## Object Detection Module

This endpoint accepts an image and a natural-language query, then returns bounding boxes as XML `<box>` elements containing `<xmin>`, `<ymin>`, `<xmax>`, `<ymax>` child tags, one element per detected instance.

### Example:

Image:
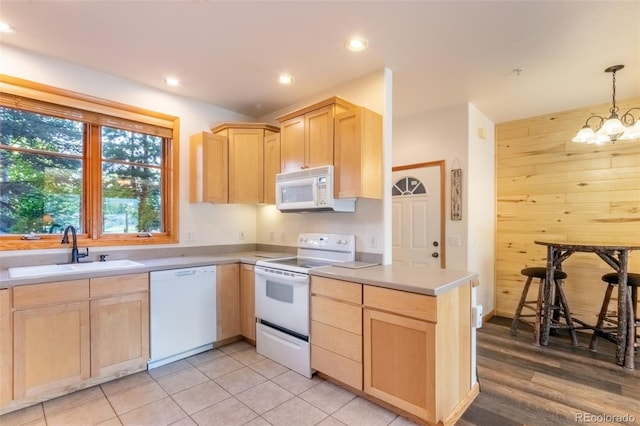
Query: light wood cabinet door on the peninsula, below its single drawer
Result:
<box><xmin>364</xmin><ymin>309</ymin><xmax>435</xmax><ymax>420</ymax></box>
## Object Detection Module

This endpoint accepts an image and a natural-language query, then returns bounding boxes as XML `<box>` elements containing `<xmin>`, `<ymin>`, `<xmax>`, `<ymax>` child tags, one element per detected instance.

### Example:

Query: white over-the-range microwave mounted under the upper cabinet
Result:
<box><xmin>276</xmin><ymin>165</ymin><xmax>356</xmax><ymax>212</ymax></box>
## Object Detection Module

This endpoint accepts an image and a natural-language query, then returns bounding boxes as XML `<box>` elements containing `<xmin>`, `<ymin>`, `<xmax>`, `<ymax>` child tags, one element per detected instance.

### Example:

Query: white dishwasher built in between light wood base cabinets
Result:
<box><xmin>147</xmin><ymin>265</ymin><xmax>216</xmax><ymax>370</ymax></box>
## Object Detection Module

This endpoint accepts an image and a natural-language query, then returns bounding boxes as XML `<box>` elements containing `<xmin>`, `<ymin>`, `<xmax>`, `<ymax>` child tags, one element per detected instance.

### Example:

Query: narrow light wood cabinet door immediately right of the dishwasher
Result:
<box><xmin>216</xmin><ymin>263</ymin><xmax>240</xmax><ymax>340</ymax></box>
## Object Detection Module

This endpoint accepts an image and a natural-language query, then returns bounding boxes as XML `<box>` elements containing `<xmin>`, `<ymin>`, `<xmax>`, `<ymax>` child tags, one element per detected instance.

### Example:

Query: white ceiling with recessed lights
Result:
<box><xmin>0</xmin><ymin>0</ymin><xmax>640</xmax><ymax>123</ymax></box>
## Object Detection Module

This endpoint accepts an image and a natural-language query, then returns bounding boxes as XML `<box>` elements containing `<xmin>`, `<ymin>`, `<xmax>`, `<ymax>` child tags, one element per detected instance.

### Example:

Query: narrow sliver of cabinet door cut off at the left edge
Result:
<box><xmin>0</xmin><ymin>288</ymin><xmax>13</xmax><ymax>408</ymax></box>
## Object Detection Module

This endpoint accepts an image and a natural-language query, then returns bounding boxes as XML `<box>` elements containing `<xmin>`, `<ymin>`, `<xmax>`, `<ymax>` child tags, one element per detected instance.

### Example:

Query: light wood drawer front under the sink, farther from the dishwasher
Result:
<box><xmin>13</xmin><ymin>280</ymin><xmax>89</xmax><ymax>309</ymax></box>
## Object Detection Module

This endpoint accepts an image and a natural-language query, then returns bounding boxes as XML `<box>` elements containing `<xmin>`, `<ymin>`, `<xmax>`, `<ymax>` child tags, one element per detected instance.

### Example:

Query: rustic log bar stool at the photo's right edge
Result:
<box><xmin>589</xmin><ymin>272</ymin><xmax>640</xmax><ymax>351</ymax></box>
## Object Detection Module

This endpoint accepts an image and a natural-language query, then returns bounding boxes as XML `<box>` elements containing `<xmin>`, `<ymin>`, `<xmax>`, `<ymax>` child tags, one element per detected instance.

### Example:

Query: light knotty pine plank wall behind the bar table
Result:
<box><xmin>496</xmin><ymin>98</ymin><xmax>640</xmax><ymax>324</ymax></box>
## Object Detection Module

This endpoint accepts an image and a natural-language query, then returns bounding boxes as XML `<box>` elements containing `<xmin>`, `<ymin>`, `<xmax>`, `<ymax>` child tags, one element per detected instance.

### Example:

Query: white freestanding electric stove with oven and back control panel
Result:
<box><xmin>255</xmin><ymin>233</ymin><xmax>355</xmax><ymax>378</ymax></box>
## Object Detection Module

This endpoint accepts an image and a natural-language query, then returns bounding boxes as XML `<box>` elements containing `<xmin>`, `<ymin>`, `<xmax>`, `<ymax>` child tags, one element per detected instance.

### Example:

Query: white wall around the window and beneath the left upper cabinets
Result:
<box><xmin>0</xmin><ymin>45</ymin><xmax>256</xmax><ymax>254</ymax></box>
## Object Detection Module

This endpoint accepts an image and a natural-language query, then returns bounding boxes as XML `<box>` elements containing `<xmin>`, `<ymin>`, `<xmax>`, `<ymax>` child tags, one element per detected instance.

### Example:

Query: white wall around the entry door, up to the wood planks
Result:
<box><xmin>393</xmin><ymin>104</ymin><xmax>495</xmax><ymax>313</ymax></box>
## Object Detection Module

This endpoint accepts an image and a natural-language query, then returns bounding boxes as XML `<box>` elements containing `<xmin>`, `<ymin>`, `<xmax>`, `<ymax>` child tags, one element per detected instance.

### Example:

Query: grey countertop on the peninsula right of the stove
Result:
<box><xmin>311</xmin><ymin>265</ymin><xmax>478</xmax><ymax>296</ymax></box>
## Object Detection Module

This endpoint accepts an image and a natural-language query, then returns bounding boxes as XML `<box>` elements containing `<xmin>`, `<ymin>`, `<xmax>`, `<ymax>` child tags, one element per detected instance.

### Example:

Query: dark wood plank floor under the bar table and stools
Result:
<box><xmin>457</xmin><ymin>318</ymin><xmax>640</xmax><ymax>426</ymax></box>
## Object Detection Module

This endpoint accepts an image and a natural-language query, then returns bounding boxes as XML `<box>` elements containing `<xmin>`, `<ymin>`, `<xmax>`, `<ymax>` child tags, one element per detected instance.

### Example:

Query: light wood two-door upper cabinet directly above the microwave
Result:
<box><xmin>276</xmin><ymin>96</ymin><xmax>356</xmax><ymax>172</ymax></box>
